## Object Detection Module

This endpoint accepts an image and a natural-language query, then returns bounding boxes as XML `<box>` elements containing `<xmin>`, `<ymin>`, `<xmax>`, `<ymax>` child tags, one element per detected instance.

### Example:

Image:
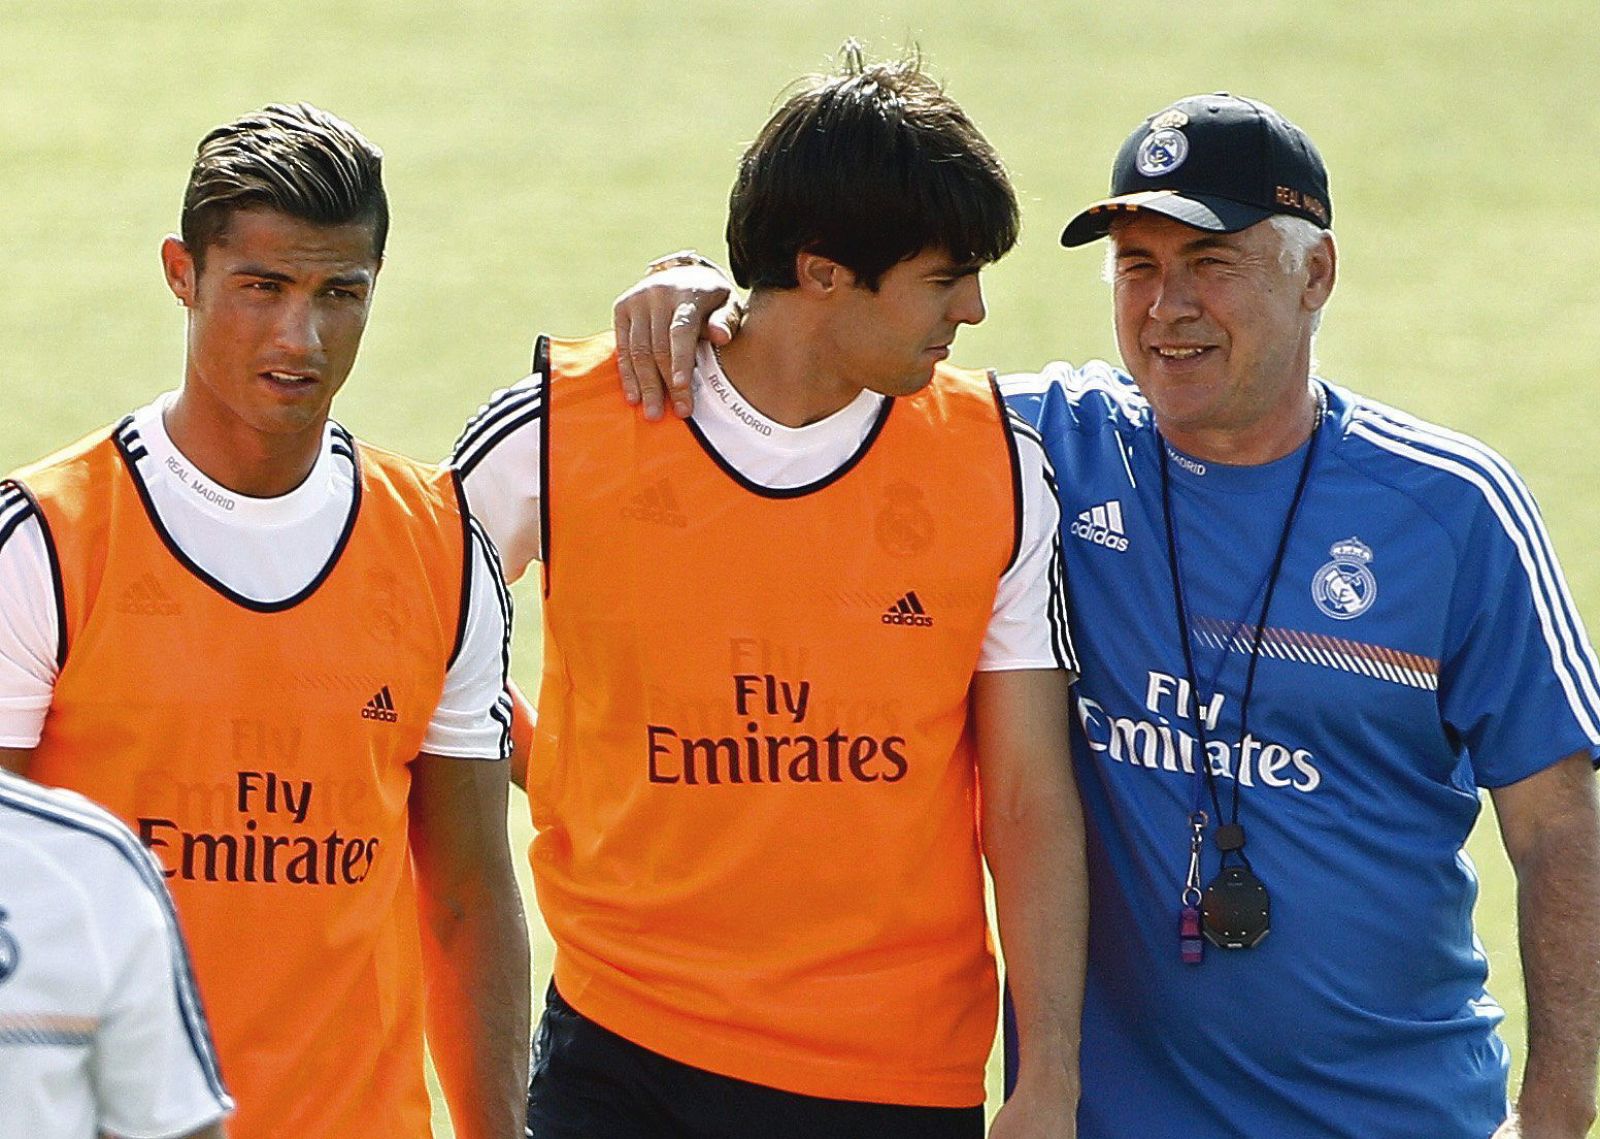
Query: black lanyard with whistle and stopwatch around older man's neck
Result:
<box><xmin>1155</xmin><ymin>386</ymin><xmax>1326</xmax><ymax>965</ymax></box>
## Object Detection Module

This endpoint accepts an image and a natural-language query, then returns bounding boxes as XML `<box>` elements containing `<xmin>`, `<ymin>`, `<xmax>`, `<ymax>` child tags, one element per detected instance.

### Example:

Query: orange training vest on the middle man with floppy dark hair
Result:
<box><xmin>528</xmin><ymin>336</ymin><xmax>1018</xmax><ymax>1107</ymax></box>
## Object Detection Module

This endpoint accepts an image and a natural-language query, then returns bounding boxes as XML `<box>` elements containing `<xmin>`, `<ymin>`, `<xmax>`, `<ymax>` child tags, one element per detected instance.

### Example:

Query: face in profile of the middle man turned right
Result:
<box><xmin>830</xmin><ymin>250</ymin><xmax>984</xmax><ymax>395</ymax></box>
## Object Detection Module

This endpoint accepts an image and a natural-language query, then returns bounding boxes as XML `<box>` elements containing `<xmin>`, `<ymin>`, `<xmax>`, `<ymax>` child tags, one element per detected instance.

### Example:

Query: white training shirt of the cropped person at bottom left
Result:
<box><xmin>0</xmin><ymin>773</ymin><xmax>234</xmax><ymax>1139</ymax></box>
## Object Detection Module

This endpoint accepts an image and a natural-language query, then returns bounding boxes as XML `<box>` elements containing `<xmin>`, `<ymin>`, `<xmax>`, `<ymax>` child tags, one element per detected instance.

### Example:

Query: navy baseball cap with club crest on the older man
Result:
<box><xmin>1061</xmin><ymin>93</ymin><xmax>1333</xmax><ymax>246</ymax></box>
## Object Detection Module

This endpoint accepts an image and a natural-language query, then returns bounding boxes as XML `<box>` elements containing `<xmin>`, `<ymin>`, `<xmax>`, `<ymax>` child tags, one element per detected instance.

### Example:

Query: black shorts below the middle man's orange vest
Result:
<box><xmin>528</xmin><ymin>984</ymin><xmax>984</xmax><ymax>1139</ymax></box>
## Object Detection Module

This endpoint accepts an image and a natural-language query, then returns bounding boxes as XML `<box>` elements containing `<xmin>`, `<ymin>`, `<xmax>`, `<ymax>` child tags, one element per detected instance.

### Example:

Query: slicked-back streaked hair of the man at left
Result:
<box><xmin>179</xmin><ymin>102</ymin><xmax>389</xmax><ymax>269</ymax></box>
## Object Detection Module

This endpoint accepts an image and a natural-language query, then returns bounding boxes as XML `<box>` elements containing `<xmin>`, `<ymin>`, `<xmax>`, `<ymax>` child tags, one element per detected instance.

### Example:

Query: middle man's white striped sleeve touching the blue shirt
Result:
<box><xmin>978</xmin><ymin>414</ymin><xmax>1078</xmax><ymax>673</ymax></box>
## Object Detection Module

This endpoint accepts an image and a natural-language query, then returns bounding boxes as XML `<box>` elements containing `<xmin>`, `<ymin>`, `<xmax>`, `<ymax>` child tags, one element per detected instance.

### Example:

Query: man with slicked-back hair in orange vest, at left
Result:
<box><xmin>0</xmin><ymin>104</ymin><xmax>528</xmax><ymax>1139</ymax></box>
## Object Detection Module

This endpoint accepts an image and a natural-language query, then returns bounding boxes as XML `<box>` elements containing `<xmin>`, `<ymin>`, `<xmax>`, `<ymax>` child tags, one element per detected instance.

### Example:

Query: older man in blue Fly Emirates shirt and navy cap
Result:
<box><xmin>621</xmin><ymin>86</ymin><xmax>1600</xmax><ymax>1139</ymax></box>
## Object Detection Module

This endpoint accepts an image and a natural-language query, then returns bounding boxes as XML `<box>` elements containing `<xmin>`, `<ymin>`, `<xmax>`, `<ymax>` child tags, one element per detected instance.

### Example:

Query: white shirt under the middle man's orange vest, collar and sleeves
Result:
<box><xmin>448</xmin><ymin>341</ymin><xmax>1075</xmax><ymax>672</ymax></box>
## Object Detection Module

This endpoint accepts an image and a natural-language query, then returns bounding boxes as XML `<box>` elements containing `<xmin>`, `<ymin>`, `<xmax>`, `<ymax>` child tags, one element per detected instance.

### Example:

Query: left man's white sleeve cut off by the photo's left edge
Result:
<box><xmin>0</xmin><ymin>485</ymin><xmax>59</xmax><ymax>747</ymax></box>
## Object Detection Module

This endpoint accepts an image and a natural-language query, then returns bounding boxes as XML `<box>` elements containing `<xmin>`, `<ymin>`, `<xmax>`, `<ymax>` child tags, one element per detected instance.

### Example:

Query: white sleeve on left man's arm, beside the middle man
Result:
<box><xmin>422</xmin><ymin>520</ymin><xmax>510</xmax><ymax>760</ymax></box>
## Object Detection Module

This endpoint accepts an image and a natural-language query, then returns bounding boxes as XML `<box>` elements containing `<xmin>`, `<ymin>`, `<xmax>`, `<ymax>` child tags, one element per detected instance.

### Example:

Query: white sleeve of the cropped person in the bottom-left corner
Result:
<box><xmin>90</xmin><ymin>835</ymin><xmax>234</xmax><ymax>1139</ymax></box>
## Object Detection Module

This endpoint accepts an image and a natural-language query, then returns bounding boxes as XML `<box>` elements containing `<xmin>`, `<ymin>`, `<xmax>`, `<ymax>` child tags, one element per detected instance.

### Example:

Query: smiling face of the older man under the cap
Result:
<box><xmin>1110</xmin><ymin>210</ymin><xmax>1333</xmax><ymax>451</ymax></box>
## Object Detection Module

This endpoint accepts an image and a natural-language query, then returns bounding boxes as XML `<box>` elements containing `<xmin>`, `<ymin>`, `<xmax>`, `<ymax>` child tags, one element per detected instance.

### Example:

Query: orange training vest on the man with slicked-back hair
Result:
<box><xmin>18</xmin><ymin>432</ymin><xmax>466</xmax><ymax>1139</ymax></box>
